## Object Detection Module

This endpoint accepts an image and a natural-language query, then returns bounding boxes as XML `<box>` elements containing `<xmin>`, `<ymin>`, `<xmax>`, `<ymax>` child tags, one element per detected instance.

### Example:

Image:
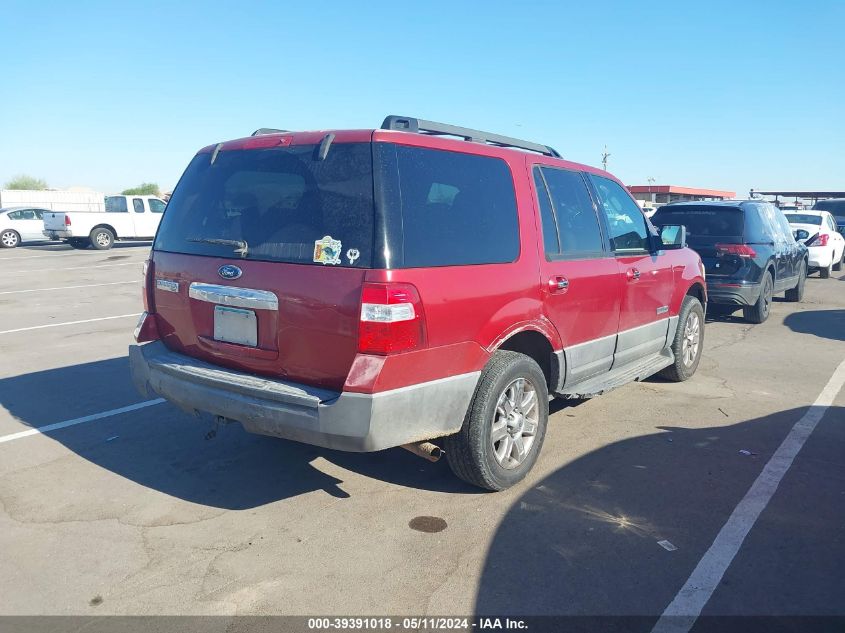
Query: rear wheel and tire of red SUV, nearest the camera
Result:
<box><xmin>444</xmin><ymin>351</ymin><xmax>549</xmax><ymax>490</ymax></box>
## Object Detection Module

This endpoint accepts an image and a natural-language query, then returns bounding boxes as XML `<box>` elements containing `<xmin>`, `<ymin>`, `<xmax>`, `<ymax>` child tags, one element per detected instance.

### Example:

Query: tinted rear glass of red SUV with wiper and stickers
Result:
<box><xmin>155</xmin><ymin>143</ymin><xmax>375</xmax><ymax>268</ymax></box>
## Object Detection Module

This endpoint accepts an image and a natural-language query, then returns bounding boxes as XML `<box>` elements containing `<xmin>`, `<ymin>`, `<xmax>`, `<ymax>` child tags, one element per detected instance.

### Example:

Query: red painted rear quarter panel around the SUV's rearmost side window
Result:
<box><xmin>354</xmin><ymin>144</ymin><xmax>548</xmax><ymax>391</ymax></box>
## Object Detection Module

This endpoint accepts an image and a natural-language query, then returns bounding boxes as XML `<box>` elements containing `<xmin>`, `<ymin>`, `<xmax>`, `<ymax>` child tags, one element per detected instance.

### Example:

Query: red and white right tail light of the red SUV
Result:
<box><xmin>358</xmin><ymin>283</ymin><xmax>426</xmax><ymax>355</ymax></box>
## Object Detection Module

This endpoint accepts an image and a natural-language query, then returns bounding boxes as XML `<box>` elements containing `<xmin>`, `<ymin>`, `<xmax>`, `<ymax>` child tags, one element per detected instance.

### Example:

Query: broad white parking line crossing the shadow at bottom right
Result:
<box><xmin>652</xmin><ymin>360</ymin><xmax>845</xmax><ymax>633</ymax></box>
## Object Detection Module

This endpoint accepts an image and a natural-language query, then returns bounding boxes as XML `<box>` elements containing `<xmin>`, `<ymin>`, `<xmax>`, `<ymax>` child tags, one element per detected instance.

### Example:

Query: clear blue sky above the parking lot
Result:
<box><xmin>0</xmin><ymin>0</ymin><xmax>845</xmax><ymax>195</ymax></box>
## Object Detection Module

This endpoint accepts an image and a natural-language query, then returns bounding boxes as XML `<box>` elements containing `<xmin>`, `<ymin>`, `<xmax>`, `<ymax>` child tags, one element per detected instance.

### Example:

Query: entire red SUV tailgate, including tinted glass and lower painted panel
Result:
<box><xmin>152</xmin><ymin>136</ymin><xmax>375</xmax><ymax>391</ymax></box>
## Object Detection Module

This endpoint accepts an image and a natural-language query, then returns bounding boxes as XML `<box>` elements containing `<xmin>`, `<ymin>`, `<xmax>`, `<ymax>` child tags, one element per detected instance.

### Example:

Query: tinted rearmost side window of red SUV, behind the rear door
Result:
<box><xmin>380</xmin><ymin>143</ymin><xmax>519</xmax><ymax>268</ymax></box>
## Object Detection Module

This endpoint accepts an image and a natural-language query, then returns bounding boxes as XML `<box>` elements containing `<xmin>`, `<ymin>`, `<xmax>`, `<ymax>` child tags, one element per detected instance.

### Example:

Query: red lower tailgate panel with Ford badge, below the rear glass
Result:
<box><xmin>152</xmin><ymin>252</ymin><xmax>365</xmax><ymax>391</ymax></box>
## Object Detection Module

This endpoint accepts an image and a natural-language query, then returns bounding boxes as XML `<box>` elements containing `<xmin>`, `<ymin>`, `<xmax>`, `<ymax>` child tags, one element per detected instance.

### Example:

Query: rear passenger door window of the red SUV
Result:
<box><xmin>535</xmin><ymin>167</ymin><xmax>604</xmax><ymax>259</ymax></box>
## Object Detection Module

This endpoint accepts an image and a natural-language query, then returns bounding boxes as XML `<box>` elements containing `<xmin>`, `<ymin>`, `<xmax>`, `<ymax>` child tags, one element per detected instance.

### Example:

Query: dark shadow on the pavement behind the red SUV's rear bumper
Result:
<box><xmin>0</xmin><ymin>357</ymin><xmax>483</xmax><ymax>510</ymax></box>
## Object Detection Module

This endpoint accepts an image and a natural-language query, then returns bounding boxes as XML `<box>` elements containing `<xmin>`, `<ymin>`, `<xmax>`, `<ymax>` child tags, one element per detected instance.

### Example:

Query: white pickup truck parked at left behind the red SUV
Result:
<box><xmin>43</xmin><ymin>196</ymin><xmax>165</xmax><ymax>250</ymax></box>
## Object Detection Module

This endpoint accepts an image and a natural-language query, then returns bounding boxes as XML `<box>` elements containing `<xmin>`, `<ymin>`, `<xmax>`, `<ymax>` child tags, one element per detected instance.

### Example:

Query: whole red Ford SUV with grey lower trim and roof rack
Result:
<box><xmin>129</xmin><ymin>116</ymin><xmax>706</xmax><ymax>490</ymax></box>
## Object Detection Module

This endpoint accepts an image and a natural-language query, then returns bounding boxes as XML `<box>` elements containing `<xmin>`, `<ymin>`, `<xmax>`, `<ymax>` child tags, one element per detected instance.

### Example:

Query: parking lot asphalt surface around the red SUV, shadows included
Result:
<box><xmin>0</xmin><ymin>244</ymin><xmax>845</xmax><ymax>630</ymax></box>
